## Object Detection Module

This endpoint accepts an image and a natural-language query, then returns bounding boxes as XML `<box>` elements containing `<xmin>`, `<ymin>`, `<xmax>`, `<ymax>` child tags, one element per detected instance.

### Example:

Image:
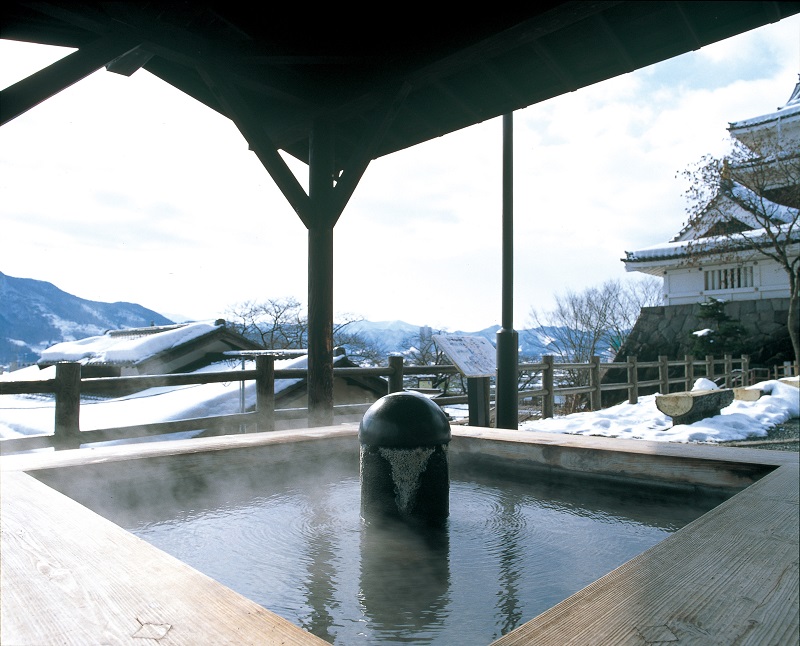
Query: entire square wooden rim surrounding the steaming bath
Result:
<box><xmin>0</xmin><ymin>425</ymin><xmax>800</xmax><ymax>646</ymax></box>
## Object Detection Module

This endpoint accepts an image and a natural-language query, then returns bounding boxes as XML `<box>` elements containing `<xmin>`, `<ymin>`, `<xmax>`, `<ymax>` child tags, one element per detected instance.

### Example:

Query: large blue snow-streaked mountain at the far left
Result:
<box><xmin>0</xmin><ymin>272</ymin><xmax>172</xmax><ymax>368</ymax></box>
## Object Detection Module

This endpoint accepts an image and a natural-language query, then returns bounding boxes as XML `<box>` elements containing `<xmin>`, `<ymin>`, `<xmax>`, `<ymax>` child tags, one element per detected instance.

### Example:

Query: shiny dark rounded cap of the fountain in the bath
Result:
<box><xmin>358</xmin><ymin>391</ymin><xmax>451</xmax><ymax>448</ymax></box>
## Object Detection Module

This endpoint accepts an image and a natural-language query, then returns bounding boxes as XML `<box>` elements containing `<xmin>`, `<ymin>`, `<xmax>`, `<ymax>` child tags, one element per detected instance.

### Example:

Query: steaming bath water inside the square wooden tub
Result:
<box><xmin>56</xmin><ymin>459</ymin><xmax>721</xmax><ymax>645</ymax></box>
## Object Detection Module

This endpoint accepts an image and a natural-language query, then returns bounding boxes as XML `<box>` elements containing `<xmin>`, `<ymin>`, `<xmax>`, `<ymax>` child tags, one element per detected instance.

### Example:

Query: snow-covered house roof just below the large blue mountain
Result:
<box><xmin>38</xmin><ymin>322</ymin><xmax>224</xmax><ymax>366</ymax></box>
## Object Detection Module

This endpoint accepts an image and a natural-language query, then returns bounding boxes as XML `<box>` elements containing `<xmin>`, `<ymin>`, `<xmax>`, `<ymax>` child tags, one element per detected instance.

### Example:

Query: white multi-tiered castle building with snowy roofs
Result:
<box><xmin>622</xmin><ymin>83</ymin><xmax>800</xmax><ymax>306</ymax></box>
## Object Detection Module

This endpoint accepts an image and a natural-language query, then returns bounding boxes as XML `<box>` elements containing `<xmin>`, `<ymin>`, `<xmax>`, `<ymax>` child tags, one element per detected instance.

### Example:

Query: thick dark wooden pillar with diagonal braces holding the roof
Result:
<box><xmin>308</xmin><ymin>123</ymin><xmax>332</xmax><ymax>426</ymax></box>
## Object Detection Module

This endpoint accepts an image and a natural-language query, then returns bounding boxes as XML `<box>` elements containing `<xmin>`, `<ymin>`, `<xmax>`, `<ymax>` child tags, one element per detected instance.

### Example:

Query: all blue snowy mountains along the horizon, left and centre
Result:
<box><xmin>0</xmin><ymin>272</ymin><xmax>564</xmax><ymax>370</ymax></box>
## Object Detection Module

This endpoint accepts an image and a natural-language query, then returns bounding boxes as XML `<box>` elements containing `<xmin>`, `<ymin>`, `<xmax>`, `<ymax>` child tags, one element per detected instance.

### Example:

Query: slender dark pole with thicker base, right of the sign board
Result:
<box><xmin>495</xmin><ymin>113</ymin><xmax>519</xmax><ymax>428</ymax></box>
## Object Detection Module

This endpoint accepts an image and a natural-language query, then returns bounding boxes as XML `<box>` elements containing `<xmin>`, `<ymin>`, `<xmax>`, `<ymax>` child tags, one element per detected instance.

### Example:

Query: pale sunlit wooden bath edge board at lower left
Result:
<box><xmin>0</xmin><ymin>472</ymin><xmax>326</xmax><ymax>646</ymax></box>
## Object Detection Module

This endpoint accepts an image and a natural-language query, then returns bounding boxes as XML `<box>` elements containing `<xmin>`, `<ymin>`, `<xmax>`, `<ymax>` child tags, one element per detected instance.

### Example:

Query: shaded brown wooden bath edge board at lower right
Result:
<box><xmin>494</xmin><ymin>466</ymin><xmax>799</xmax><ymax>646</ymax></box>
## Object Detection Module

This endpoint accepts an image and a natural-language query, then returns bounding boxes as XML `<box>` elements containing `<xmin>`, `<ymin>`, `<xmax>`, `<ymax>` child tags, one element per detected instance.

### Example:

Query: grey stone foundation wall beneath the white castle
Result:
<box><xmin>616</xmin><ymin>298</ymin><xmax>793</xmax><ymax>366</ymax></box>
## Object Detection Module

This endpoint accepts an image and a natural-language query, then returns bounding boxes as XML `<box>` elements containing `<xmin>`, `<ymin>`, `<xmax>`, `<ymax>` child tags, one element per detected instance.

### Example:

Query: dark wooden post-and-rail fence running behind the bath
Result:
<box><xmin>0</xmin><ymin>355</ymin><xmax>764</xmax><ymax>453</ymax></box>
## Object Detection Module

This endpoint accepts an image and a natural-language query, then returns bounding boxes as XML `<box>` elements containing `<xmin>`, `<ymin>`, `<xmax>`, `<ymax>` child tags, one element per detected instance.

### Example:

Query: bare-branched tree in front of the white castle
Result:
<box><xmin>681</xmin><ymin>131</ymin><xmax>800</xmax><ymax>363</ymax></box>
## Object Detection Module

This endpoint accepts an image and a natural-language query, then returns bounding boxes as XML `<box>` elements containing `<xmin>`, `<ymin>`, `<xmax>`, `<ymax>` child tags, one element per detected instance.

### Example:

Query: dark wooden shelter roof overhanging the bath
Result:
<box><xmin>6</xmin><ymin>0</ymin><xmax>800</xmax><ymax>176</ymax></box>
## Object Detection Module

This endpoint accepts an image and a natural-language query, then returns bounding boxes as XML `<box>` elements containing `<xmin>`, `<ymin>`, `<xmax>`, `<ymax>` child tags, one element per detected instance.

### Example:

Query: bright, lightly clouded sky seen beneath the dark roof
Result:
<box><xmin>0</xmin><ymin>16</ymin><xmax>800</xmax><ymax>331</ymax></box>
